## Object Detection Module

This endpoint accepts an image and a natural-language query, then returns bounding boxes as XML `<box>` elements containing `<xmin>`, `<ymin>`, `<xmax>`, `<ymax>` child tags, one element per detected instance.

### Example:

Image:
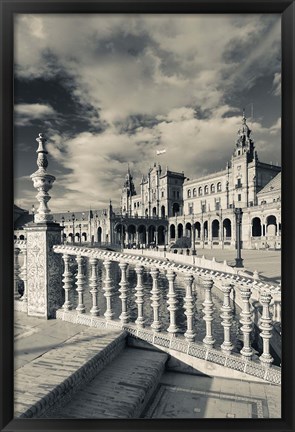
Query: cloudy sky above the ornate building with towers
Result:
<box><xmin>14</xmin><ymin>14</ymin><xmax>281</xmax><ymax>211</ymax></box>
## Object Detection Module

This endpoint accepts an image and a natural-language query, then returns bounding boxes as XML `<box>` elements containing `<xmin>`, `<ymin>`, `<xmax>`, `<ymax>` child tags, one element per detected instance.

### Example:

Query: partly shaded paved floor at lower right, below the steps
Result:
<box><xmin>144</xmin><ymin>372</ymin><xmax>281</xmax><ymax>418</ymax></box>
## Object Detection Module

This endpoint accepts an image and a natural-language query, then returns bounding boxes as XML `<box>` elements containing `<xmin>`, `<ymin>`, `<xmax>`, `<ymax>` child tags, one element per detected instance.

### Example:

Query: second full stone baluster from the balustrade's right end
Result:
<box><xmin>240</xmin><ymin>286</ymin><xmax>253</xmax><ymax>360</ymax></box>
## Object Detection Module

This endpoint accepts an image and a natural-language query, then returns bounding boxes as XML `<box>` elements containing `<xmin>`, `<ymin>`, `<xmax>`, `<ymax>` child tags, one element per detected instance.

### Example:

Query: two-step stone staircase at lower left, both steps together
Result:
<box><xmin>14</xmin><ymin>328</ymin><xmax>168</xmax><ymax>418</ymax></box>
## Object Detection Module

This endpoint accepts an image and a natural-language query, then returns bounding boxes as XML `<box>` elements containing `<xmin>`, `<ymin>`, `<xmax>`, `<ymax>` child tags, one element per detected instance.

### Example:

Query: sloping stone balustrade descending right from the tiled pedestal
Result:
<box><xmin>49</xmin><ymin>245</ymin><xmax>280</xmax><ymax>384</ymax></box>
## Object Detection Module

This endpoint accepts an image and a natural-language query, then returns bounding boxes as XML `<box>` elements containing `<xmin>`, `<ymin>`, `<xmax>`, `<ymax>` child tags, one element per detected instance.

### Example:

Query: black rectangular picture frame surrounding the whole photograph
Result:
<box><xmin>0</xmin><ymin>0</ymin><xmax>295</xmax><ymax>432</ymax></box>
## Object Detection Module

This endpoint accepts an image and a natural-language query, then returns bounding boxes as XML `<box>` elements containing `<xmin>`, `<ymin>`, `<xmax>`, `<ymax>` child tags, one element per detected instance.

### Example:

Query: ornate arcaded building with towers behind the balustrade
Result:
<box><xmin>15</xmin><ymin>116</ymin><xmax>281</xmax><ymax>249</ymax></box>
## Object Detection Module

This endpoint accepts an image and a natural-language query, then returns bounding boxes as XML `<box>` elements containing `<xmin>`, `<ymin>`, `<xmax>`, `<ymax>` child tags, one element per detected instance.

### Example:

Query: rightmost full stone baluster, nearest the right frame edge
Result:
<box><xmin>259</xmin><ymin>292</ymin><xmax>273</xmax><ymax>366</ymax></box>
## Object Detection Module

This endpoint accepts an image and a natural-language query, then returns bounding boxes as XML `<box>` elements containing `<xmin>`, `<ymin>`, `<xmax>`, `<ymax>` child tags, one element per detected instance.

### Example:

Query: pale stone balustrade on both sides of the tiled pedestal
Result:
<box><xmin>15</xmin><ymin>241</ymin><xmax>280</xmax><ymax>383</ymax></box>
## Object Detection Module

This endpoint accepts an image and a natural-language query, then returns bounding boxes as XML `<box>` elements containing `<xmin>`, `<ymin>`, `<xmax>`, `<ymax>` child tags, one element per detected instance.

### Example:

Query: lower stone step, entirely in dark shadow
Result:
<box><xmin>46</xmin><ymin>348</ymin><xmax>168</xmax><ymax>419</ymax></box>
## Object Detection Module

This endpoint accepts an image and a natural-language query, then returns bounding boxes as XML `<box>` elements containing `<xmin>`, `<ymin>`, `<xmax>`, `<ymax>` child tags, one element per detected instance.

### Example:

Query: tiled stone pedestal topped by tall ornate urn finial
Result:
<box><xmin>25</xmin><ymin>134</ymin><xmax>63</xmax><ymax>318</ymax></box>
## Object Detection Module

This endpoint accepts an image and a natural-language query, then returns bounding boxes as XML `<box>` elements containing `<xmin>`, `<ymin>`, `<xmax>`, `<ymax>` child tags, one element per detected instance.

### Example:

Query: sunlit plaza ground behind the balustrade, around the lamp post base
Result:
<box><xmin>197</xmin><ymin>249</ymin><xmax>281</xmax><ymax>283</ymax></box>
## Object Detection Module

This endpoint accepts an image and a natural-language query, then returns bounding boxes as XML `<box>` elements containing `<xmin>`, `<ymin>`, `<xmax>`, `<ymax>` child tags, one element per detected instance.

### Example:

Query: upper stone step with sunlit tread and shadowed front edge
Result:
<box><xmin>14</xmin><ymin>328</ymin><xmax>126</xmax><ymax>418</ymax></box>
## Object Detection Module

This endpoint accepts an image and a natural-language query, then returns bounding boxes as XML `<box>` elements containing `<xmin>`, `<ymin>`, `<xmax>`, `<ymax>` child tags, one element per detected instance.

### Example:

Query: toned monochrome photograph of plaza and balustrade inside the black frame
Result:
<box><xmin>13</xmin><ymin>13</ymin><xmax>284</xmax><ymax>420</ymax></box>
